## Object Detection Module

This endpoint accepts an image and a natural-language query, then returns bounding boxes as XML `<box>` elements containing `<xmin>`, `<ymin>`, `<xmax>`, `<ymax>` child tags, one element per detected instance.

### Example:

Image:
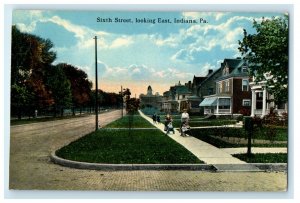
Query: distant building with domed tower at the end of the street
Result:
<box><xmin>140</xmin><ymin>85</ymin><xmax>162</xmax><ymax>110</ymax></box>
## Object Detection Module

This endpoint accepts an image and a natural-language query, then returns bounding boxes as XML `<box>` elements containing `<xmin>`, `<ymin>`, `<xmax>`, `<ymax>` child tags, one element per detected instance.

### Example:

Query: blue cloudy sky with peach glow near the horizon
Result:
<box><xmin>13</xmin><ymin>10</ymin><xmax>282</xmax><ymax>96</ymax></box>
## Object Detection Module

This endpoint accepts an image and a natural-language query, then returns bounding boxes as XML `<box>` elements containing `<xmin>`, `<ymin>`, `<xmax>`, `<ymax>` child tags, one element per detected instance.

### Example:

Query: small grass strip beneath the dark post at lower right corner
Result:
<box><xmin>233</xmin><ymin>153</ymin><xmax>288</xmax><ymax>163</ymax></box>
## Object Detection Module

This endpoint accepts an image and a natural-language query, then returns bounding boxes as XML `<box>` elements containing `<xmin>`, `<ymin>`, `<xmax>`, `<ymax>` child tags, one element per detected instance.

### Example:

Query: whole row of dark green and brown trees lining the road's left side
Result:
<box><xmin>11</xmin><ymin>26</ymin><xmax>122</xmax><ymax>118</ymax></box>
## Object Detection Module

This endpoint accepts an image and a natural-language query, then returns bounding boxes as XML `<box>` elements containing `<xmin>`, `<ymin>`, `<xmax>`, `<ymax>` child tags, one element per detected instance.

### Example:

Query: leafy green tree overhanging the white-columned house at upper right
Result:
<box><xmin>239</xmin><ymin>15</ymin><xmax>289</xmax><ymax>104</ymax></box>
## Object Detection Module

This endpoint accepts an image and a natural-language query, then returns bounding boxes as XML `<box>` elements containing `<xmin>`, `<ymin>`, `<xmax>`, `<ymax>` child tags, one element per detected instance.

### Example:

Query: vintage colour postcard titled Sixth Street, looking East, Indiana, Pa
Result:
<box><xmin>9</xmin><ymin>10</ymin><xmax>290</xmax><ymax>192</ymax></box>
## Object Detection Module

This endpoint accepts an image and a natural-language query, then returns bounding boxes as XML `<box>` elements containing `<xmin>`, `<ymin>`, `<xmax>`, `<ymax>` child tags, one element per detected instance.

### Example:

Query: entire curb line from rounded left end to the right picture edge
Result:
<box><xmin>50</xmin><ymin>152</ymin><xmax>287</xmax><ymax>172</ymax></box>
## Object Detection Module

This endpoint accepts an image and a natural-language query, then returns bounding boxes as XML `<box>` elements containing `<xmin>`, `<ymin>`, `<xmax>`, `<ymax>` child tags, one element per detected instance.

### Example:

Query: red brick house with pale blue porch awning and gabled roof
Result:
<box><xmin>200</xmin><ymin>58</ymin><xmax>251</xmax><ymax>116</ymax></box>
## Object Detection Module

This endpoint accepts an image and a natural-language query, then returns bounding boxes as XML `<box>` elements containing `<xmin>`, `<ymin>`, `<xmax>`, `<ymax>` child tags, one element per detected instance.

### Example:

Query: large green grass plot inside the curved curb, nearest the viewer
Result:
<box><xmin>56</xmin><ymin>129</ymin><xmax>203</xmax><ymax>164</ymax></box>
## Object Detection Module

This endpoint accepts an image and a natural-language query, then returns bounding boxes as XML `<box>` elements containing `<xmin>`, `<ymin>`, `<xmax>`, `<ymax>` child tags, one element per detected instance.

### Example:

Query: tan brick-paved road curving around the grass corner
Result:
<box><xmin>9</xmin><ymin>111</ymin><xmax>287</xmax><ymax>191</ymax></box>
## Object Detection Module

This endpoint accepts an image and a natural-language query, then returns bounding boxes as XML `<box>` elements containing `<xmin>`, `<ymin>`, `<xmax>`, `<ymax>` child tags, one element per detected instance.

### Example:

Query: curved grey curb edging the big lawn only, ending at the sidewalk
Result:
<box><xmin>50</xmin><ymin>152</ymin><xmax>216</xmax><ymax>172</ymax></box>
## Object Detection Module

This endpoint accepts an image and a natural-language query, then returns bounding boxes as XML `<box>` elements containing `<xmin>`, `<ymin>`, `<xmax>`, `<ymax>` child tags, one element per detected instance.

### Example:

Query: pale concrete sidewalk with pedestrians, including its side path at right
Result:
<box><xmin>139</xmin><ymin>111</ymin><xmax>286</xmax><ymax>171</ymax></box>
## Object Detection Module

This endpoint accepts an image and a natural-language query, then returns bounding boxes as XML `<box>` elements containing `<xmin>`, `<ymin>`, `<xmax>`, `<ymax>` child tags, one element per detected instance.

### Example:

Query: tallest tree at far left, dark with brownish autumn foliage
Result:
<box><xmin>11</xmin><ymin>26</ymin><xmax>56</xmax><ymax>118</ymax></box>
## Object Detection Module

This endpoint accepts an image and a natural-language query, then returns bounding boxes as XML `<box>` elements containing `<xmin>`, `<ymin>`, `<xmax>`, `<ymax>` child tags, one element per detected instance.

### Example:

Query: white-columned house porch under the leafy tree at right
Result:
<box><xmin>249</xmin><ymin>74</ymin><xmax>288</xmax><ymax>117</ymax></box>
